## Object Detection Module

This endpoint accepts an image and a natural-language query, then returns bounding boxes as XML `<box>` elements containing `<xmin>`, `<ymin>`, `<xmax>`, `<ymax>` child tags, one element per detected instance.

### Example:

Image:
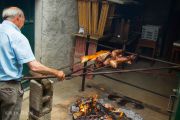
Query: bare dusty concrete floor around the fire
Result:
<box><xmin>20</xmin><ymin>62</ymin><xmax>177</xmax><ymax>120</ymax></box>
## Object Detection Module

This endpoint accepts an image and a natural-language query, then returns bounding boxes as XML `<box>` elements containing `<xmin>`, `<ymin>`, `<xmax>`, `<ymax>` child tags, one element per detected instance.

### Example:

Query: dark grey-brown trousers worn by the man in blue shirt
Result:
<box><xmin>0</xmin><ymin>81</ymin><xmax>23</xmax><ymax>120</ymax></box>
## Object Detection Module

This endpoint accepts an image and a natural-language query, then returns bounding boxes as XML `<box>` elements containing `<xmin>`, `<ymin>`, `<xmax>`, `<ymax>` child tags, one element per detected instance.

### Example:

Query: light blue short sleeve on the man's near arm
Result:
<box><xmin>11</xmin><ymin>33</ymin><xmax>35</xmax><ymax>64</ymax></box>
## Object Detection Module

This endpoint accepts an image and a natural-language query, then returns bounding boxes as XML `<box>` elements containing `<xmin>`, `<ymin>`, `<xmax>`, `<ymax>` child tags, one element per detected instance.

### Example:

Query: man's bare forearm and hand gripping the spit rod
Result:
<box><xmin>27</xmin><ymin>60</ymin><xmax>65</xmax><ymax>80</ymax></box>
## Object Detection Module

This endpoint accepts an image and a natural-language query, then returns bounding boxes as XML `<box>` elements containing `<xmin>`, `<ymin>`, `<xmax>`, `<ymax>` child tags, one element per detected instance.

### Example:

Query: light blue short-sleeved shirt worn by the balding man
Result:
<box><xmin>0</xmin><ymin>20</ymin><xmax>35</xmax><ymax>81</ymax></box>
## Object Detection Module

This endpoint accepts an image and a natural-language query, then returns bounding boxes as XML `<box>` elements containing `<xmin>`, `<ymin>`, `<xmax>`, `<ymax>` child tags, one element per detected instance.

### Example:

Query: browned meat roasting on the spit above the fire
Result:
<box><xmin>81</xmin><ymin>49</ymin><xmax>135</xmax><ymax>68</ymax></box>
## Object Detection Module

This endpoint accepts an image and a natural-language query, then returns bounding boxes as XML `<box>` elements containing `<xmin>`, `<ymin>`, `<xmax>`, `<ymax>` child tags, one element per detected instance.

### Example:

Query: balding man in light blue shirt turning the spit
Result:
<box><xmin>0</xmin><ymin>7</ymin><xmax>65</xmax><ymax>120</ymax></box>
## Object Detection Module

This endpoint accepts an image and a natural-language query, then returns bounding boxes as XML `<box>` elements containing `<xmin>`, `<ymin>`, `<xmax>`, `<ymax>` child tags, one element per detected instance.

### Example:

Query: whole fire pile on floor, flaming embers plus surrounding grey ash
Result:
<box><xmin>70</xmin><ymin>96</ymin><xmax>143</xmax><ymax>120</ymax></box>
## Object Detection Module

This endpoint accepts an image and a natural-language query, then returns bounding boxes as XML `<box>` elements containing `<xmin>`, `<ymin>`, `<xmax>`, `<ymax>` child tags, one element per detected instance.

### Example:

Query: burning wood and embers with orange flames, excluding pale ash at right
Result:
<box><xmin>71</xmin><ymin>95</ymin><xmax>124</xmax><ymax>120</ymax></box>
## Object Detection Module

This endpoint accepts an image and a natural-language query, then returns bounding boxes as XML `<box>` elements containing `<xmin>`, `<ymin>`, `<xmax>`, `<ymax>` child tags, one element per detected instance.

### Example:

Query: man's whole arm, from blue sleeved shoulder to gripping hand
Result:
<box><xmin>11</xmin><ymin>32</ymin><xmax>65</xmax><ymax>80</ymax></box>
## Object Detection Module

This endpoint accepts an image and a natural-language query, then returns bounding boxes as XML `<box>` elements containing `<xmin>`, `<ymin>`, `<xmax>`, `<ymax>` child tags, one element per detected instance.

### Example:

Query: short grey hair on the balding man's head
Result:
<box><xmin>2</xmin><ymin>7</ymin><xmax>24</xmax><ymax>20</ymax></box>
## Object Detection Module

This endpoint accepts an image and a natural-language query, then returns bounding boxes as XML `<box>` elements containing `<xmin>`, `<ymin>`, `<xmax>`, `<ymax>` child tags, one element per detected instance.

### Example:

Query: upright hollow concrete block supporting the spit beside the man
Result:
<box><xmin>29</xmin><ymin>79</ymin><xmax>53</xmax><ymax>120</ymax></box>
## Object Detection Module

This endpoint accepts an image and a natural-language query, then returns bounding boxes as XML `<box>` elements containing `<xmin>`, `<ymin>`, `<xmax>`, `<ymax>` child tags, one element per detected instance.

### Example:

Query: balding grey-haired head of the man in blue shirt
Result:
<box><xmin>2</xmin><ymin>7</ymin><xmax>25</xmax><ymax>29</ymax></box>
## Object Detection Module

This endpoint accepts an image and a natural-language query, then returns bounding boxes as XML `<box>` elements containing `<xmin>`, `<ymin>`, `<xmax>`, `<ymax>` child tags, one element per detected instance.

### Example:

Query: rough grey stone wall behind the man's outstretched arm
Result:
<box><xmin>35</xmin><ymin>0</ymin><xmax>78</xmax><ymax>68</ymax></box>
